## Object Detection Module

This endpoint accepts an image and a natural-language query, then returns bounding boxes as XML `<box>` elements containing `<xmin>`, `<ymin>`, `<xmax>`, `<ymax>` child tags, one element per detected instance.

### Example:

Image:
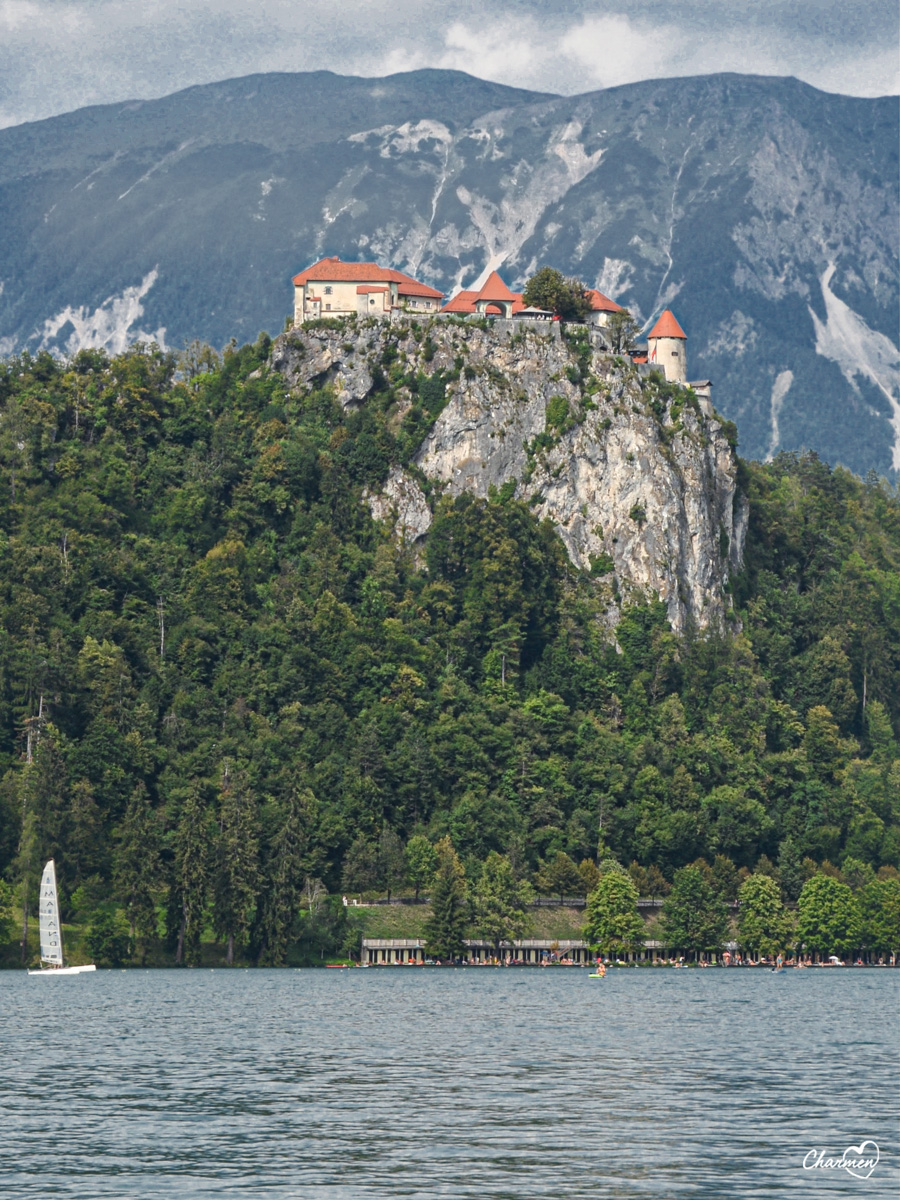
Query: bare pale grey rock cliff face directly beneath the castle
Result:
<box><xmin>272</xmin><ymin>319</ymin><xmax>745</xmax><ymax>629</ymax></box>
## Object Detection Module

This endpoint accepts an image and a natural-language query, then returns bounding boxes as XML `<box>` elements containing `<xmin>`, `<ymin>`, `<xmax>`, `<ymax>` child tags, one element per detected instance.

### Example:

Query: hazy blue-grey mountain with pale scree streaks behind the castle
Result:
<box><xmin>0</xmin><ymin>71</ymin><xmax>900</xmax><ymax>472</ymax></box>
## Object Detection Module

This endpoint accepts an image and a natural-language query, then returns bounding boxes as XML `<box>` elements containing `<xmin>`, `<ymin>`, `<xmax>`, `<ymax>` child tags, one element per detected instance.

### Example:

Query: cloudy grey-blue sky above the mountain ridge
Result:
<box><xmin>0</xmin><ymin>0</ymin><xmax>900</xmax><ymax>127</ymax></box>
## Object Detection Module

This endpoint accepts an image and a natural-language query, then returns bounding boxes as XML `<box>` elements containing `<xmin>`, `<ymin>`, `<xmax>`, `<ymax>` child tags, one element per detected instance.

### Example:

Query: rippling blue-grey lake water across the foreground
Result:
<box><xmin>0</xmin><ymin>967</ymin><xmax>900</xmax><ymax>1200</ymax></box>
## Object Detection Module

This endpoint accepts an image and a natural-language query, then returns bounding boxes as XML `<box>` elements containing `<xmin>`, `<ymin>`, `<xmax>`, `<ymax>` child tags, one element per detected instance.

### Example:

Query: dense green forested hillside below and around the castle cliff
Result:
<box><xmin>0</xmin><ymin>336</ymin><xmax>900</xmax><ymax>962</ymax></box>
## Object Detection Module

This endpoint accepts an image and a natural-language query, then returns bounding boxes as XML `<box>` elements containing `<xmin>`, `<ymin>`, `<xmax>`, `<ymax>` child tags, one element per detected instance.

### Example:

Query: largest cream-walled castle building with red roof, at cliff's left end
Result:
<box><xmin>293</xmin><ymin>256</ymin><xmax>444</xmax><ymax>325</ymax></box>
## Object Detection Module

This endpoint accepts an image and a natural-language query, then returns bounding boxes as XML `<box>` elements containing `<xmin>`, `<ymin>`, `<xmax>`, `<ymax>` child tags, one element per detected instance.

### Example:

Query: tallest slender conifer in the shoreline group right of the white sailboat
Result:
<box><xmin>212</xmin><ymin>772</ymin><xmax>259</xmax><ymax>966</ymax></box>
